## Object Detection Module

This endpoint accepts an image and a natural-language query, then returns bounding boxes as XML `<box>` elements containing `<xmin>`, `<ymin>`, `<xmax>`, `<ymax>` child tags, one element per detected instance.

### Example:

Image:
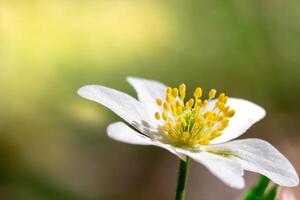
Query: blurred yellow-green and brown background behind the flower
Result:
<box><xmin>0</xmin><ymin>0</ymin><xmax>300</xmax><ymax>200</ymax></box>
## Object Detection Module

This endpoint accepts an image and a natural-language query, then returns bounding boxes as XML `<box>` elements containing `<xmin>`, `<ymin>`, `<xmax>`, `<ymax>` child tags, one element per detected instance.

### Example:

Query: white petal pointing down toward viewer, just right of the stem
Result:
<box><xmin>183</xmin><ymin>152</ymin><xmax>245</xmax><ymax>189</ymax></box>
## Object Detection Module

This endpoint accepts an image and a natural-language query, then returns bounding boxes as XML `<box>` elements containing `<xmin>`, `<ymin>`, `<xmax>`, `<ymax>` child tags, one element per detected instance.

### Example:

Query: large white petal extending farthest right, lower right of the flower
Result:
<box><xmin>205</xmin><ymin>139</ymin><xmax>299</xmax><ymax>187</ymax></box>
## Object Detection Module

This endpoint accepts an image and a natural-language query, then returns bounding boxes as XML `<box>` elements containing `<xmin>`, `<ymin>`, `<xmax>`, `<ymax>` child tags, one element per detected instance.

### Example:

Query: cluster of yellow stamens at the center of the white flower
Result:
<box><xmin>155</xmin><ymin>84</ymin><xmax>235</xmax><ymax>146</ymax></box>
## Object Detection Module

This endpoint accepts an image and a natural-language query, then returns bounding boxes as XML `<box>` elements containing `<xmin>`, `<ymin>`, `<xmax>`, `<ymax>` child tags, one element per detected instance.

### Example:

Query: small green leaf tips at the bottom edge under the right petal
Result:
<box><xmin>244</xmin><ymin>176</ymin><xmax>278</xmax><ymax>200</ymax></box>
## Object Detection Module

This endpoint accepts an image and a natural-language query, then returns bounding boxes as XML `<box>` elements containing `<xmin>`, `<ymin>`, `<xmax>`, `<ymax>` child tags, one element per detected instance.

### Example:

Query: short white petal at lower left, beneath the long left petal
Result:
<box><xmin>107</xmin><ymin>122</ymin><xmax>186</xmax><ymax>160</ymax></box>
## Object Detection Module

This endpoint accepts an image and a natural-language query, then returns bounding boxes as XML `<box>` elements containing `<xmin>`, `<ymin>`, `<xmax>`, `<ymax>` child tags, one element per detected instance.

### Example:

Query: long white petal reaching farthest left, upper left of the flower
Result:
<box><xmin>78</xmin><ymin>85</ymin><xmax>156</xmax><ymax>134</ymax></box>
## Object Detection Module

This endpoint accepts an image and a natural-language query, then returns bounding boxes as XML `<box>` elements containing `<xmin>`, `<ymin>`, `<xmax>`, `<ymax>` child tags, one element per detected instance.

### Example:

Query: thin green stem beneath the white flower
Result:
<box><xmin>175</xmin><ymin>157</ymin><xmax>190</xmax><ymax>200</ymax></box>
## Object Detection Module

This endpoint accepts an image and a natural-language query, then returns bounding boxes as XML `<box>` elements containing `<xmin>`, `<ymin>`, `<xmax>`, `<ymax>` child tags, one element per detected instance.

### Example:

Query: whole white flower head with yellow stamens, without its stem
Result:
<box><xmin>78</xmin><ymin>77</ymin><xmax>299</xmax><ymax>188</ymax></box>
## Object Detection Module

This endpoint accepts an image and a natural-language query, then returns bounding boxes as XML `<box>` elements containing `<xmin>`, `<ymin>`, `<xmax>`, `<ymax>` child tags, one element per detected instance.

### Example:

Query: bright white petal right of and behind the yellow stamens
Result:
<box><xmin>211</xmin><ymin>98</ymin><xmax>266</xmax><ymax>144</ymax></box>
